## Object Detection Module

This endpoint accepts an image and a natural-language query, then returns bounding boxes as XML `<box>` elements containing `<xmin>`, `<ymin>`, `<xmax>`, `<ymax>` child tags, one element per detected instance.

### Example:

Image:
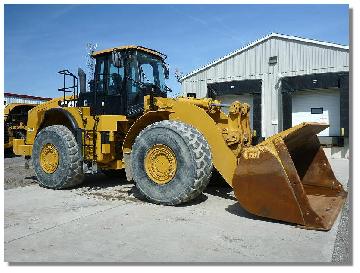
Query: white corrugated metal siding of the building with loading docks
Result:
<box><xmin>182</xmin><ymin>38</ymin><xmax>349</xmax><ymax>137</ymax></box>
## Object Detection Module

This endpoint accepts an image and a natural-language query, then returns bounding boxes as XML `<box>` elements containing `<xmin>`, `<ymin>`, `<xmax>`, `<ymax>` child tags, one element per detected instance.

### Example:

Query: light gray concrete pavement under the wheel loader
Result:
<box><xmin>4</xmin><ymin>159</ymin><xmax>349</xmax><ymax>262</ymax></box>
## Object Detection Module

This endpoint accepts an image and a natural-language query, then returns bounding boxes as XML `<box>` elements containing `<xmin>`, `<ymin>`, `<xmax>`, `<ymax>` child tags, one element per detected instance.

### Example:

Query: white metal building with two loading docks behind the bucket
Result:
<box><xmin>180</xmin><ymin>33</ymin><xmax>349</xmax><ymax>153</ymax></box>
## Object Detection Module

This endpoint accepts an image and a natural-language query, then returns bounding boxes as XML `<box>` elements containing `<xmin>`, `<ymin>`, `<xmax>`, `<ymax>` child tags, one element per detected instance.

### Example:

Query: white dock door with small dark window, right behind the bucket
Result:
<box><xmin>292</xmin><ymin>88</ymin><xmax>340</xmax><ymax>136</ymax></box>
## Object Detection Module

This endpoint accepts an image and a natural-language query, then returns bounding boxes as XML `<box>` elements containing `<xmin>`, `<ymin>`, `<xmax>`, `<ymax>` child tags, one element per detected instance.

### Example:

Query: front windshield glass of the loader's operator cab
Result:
<box><xmin>131</xmin><ymin>51</ymin><xmax>166</xmax><ymax>92</ymax></box>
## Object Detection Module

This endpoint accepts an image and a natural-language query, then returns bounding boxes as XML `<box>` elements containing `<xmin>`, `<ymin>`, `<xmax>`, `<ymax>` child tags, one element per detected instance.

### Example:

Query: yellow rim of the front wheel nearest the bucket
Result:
<box><xmin>144</xmin><ymin>144</ymin><xmax>177</xmax><ymax>185</ymax></box>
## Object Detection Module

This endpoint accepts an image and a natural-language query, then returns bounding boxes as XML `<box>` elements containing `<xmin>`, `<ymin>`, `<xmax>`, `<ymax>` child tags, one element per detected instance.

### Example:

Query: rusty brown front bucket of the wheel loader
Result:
<box><xmin>232</xmin><ymin>123</ymin><xmax>347</xmax><ymax>230</ymax></box>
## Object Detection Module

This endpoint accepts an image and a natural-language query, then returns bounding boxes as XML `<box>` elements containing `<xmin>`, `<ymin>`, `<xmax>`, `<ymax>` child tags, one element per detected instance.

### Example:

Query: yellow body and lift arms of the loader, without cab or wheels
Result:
<box><xmin>14</xmin><ymin>96</ymin><xmax>252</xmax><ymax>177</ymax></box>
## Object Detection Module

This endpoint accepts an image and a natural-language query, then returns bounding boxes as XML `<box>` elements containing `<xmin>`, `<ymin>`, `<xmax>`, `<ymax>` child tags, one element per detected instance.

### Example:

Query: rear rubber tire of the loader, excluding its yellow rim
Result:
<box><xmin>32</xmin><ymin>125</ymin><xmax>84</xmax><ymax>189</ymax></box>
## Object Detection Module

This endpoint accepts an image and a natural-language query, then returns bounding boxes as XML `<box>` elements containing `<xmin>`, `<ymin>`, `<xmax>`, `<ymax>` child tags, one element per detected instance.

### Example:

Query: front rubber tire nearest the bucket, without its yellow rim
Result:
<box><xmin>131</xmin><ymin>120</ymin><xmax>212</xmax><ymax>205</ymax></box>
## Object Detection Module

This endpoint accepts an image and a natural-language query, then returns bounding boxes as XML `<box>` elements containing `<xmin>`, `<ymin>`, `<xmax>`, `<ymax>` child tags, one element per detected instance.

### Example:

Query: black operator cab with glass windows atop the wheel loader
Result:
<box><xmin>78</xmin><ymin>46</ymin><xmax>170</xmax><ymax>117</ymax></box>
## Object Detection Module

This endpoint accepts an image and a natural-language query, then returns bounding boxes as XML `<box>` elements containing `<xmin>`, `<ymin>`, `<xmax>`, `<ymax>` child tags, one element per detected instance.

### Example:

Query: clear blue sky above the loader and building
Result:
<box><xmin>5</xmin><ymin>5</ymin><xmax>349</xmax><ymax>97</ymax></box>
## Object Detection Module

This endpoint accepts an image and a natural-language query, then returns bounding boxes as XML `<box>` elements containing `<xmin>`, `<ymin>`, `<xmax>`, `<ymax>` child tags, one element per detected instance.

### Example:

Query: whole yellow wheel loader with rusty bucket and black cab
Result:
<box><xmin>13</xmin><ymin>46</ymin><xmax>347</xmax><ymax>230</ymax></box>
